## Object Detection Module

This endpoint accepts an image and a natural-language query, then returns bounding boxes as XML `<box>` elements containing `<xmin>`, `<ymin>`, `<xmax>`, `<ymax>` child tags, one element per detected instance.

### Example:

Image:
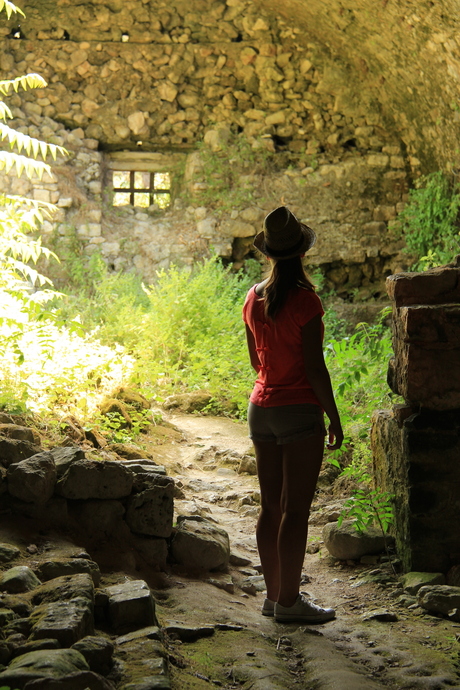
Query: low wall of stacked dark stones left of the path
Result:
<box><xmin>0</xmin><ymin>408</ymin><xmax>235</xmax><ymax>577</ymax></box>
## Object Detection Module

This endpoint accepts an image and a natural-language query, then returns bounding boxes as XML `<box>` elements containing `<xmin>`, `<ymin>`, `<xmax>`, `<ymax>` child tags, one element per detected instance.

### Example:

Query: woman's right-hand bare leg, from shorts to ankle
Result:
<box><xmin>276</xmin><ymin>434</ymin><xmax>324</xmax><ymax>606</ymax></box>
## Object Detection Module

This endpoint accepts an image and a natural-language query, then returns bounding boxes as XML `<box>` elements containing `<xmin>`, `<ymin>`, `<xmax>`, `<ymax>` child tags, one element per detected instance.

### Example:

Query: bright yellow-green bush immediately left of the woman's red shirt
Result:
<box><xmin>138</xmin><ymin>257</ymin><xmax>252</xmax><ymax>415</ymax></box>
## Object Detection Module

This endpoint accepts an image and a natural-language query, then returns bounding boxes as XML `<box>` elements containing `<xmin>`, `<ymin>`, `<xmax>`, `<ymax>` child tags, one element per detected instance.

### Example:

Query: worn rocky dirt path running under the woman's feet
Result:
<box><xmin>0</xmin><ymin>414</ymin><xmax>460</xmax><ymax>690</ymax></box>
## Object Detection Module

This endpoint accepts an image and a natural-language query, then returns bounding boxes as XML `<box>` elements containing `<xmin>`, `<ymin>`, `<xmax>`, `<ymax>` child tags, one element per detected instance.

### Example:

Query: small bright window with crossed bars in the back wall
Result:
<box><xmin>112</xmin><ymin>170</ymin><xmax>171</xmax><ymax>208</ymax></box>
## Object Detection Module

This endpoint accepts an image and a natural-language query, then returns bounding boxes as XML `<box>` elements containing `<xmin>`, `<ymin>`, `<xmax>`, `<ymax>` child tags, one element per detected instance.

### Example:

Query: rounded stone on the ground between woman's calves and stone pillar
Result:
<box><xmin>323</xmin><ymin>520</ymin><xmax>392</xmax><ymax>561</ymax></box>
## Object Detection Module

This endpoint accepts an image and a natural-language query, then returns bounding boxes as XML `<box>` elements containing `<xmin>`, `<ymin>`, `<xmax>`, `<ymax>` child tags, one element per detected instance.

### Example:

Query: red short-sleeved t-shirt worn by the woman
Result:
<box><xmin>243</xmin><ymin>285</ymin><xmax>324</xmax><ymax>407</ymax></box>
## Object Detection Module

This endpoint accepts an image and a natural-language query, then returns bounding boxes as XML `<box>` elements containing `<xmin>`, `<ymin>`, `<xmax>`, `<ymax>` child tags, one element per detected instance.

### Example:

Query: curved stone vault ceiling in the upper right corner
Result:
<box><xmin>254</xmin><ymin>0</ymin><xmax>460</xmax><ymax>171</ymax></box>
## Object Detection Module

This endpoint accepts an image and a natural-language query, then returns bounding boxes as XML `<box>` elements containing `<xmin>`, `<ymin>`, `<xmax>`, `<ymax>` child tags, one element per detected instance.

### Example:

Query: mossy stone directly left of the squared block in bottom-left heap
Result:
<box><xmin>30</xmin><ymin>598</ymin><xmax>94</xmax><ymax>647</ymax></box>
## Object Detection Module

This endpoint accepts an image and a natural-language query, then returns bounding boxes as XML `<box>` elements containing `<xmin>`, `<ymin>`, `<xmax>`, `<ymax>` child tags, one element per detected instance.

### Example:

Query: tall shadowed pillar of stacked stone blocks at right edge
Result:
<box><xmin>372</xmin><ymin>257</ymin><xmax>460</xmax><ymax>572</ymax></box>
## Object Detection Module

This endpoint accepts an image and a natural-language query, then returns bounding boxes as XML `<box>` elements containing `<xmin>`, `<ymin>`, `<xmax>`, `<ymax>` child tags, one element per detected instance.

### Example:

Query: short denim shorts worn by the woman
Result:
<box><xmin>248</xmin><ymin>402</ymin><xmax>326</xmax><ymax>445</ymax></box>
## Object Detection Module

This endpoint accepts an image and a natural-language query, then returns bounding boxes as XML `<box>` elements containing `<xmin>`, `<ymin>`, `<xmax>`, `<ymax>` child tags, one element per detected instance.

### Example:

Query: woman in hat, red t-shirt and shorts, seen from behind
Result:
<box><xmin>243</xmin><ymin>206</ymin><xmax>343</xmax><ymax>623</ymax></box>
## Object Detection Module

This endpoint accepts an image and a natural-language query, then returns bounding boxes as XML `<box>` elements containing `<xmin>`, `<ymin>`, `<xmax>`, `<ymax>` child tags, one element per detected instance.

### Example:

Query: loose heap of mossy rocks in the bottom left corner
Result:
<box><xmin>0</xmin><ymin>544</ymin><xmax>170</xmax><ymax>690</ymax></box>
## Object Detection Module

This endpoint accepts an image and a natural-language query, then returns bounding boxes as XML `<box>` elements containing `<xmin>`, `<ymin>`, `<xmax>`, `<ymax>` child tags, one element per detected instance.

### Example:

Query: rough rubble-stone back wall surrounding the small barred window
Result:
<box><xmin>0</xmin><ymin>0</ymin><xmax>438</xmax><ymax>288</ymax></box>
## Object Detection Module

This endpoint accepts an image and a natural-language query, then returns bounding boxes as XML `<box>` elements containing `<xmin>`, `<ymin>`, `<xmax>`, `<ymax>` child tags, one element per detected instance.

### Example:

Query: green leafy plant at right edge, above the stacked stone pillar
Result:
<box><xmin>393</xmin><ymin>171</ymin><xmax>460</xmax><ymax>270</ymax></box>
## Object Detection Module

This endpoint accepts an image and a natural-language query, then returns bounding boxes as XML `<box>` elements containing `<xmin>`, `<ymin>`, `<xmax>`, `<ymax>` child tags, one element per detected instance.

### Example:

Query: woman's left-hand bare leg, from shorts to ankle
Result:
<box><xmin>254</xmin><ymin>441</ymin><xmax>283</xmax><ymax>601</ymax></box>
